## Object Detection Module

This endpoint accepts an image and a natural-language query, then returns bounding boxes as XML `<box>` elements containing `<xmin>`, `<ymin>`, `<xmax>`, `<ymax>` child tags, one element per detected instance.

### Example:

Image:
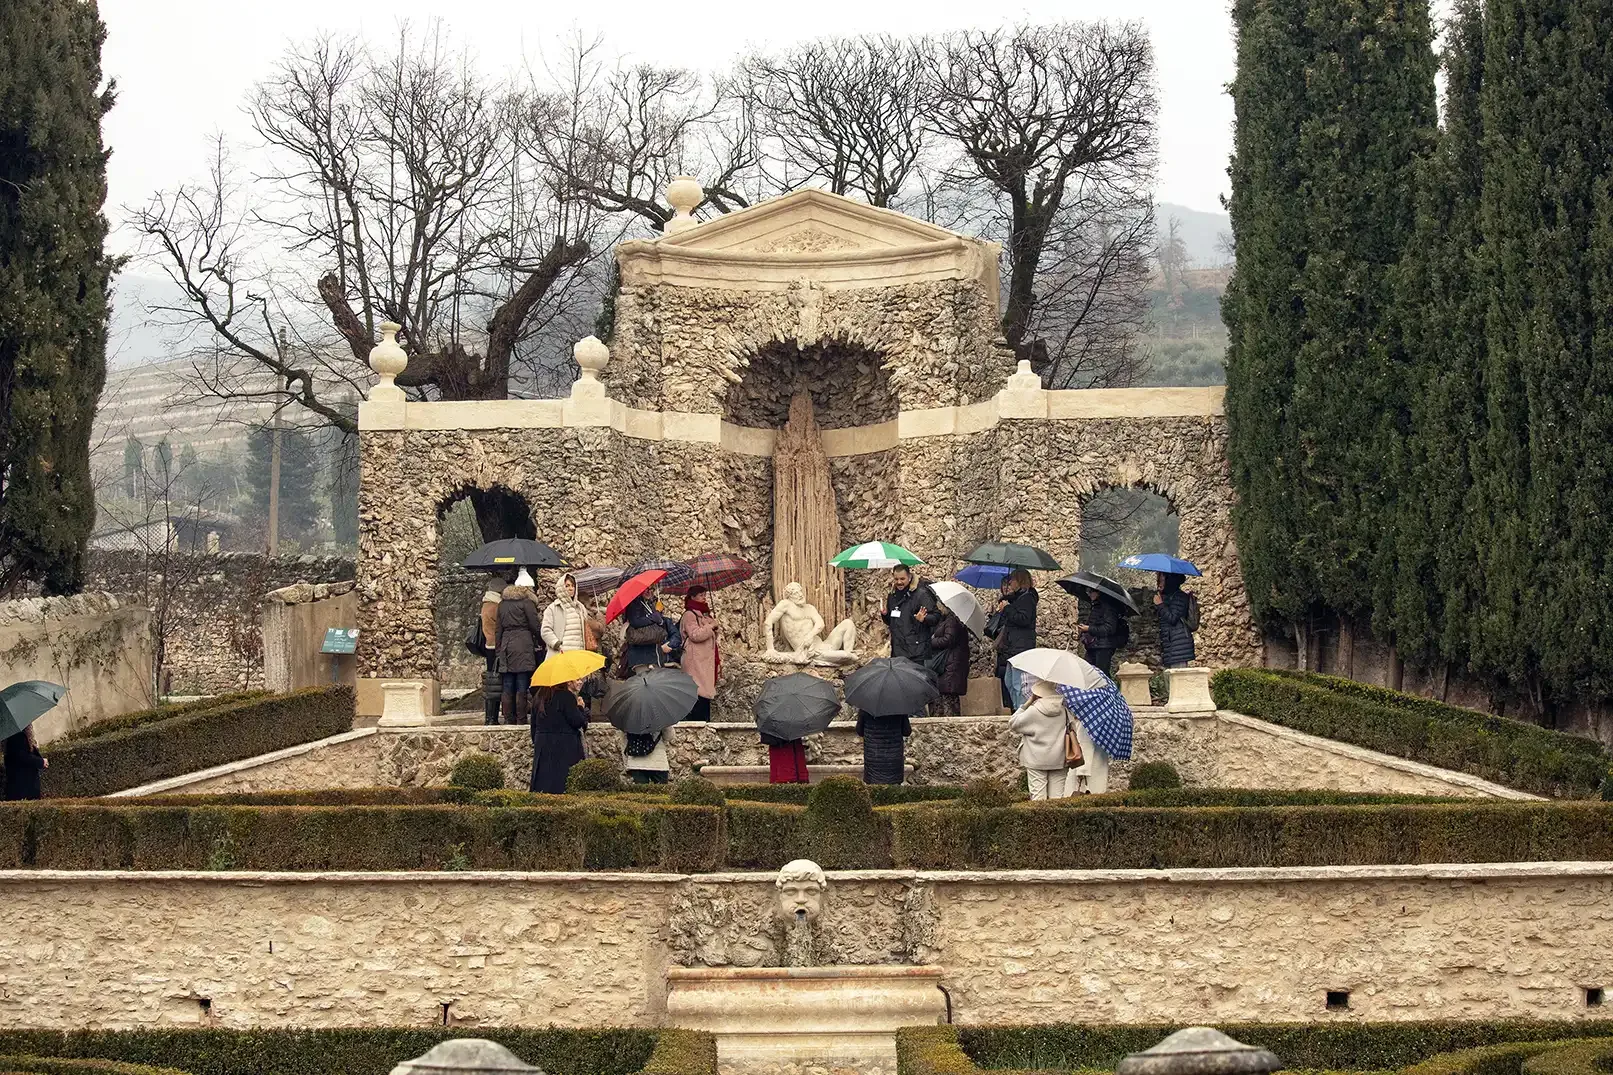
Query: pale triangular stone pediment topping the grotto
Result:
<box><xmin>658</xmin><ymin>190</ymin><xmax>960</xmax><ymax>258</ymax></box>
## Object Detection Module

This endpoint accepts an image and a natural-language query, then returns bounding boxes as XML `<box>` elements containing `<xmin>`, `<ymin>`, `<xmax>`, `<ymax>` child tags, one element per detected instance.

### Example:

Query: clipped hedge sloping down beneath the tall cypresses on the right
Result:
<box><xmin>1210</xmin><ymin>668</ymin><xmax>1613</xmax><ymax>799</ymax></box>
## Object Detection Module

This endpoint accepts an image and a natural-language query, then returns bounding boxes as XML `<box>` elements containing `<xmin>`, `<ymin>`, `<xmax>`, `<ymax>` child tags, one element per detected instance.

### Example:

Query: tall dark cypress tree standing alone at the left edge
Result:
<box><xmin>0</xmin><ymin>0</ymin><xmax>113</xmax><ymax>594</ymax></box>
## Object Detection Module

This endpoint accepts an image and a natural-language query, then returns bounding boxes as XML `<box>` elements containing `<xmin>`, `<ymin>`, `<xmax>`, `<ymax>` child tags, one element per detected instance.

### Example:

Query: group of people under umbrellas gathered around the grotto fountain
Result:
<box><xmin>466</xmin><ymin>567</ymin><xmax>1197</xmax><ymax>799</ymax></box>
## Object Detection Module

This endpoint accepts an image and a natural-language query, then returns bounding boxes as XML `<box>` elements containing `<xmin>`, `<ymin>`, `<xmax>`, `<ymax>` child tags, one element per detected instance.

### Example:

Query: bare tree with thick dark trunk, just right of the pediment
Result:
<box><xmin>931</xmin><ymin>23</ymin><xmax>1158</xmax><ymax>376</ymax></box>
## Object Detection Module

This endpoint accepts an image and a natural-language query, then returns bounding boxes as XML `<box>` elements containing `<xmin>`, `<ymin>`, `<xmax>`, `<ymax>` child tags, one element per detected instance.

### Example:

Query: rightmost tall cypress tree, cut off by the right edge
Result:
<box><xmin>1473</xmin><ymin>0</ymin><xmax>1613</xmax><ymax>705</ymax></box>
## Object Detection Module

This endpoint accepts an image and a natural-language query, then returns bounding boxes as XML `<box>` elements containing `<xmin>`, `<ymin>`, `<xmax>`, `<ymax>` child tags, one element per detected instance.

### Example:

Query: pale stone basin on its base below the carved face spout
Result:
<box><xmin>666</xmin><ymin>965</ymin><xmax>947</xmax><ymax>1070</ymax></box>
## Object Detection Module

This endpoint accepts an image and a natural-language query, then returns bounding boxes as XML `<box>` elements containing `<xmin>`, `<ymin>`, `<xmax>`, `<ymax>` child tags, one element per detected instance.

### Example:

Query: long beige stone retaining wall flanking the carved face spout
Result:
<box><xmin>0</xmin><ymin>862</ymin><xmax>1613</xmax><ymax>1030</ymax></box>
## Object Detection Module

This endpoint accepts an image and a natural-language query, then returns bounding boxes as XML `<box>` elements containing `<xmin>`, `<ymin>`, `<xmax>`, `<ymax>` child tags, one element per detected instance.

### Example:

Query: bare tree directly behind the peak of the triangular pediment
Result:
<box><xmin>727</xmin><ymin>36</ymin><xmax>929</xmax><ymax>208</ymax></box>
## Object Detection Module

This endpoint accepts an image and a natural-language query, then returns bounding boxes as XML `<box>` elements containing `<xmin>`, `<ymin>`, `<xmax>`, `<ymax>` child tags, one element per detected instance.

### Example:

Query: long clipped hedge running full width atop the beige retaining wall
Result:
<box><xmin>0</xmin><ymin>789</ymin><xmax>1613</xmax><ymax>873</ymax></box>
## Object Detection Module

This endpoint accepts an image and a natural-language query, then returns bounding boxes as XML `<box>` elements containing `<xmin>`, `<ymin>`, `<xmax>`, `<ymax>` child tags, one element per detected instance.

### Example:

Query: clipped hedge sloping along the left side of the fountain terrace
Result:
<box><xmin>42</xmin><ymin>686</ymin><xmax>353</xmax><ymax>799</ymax></box>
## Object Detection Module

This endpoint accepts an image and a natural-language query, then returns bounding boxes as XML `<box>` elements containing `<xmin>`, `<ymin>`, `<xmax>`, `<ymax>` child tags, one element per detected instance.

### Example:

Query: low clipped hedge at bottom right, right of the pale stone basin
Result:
<box><xmin>897</xmin><ymin>1020</ymin><xmax>1613</xmax><ymax>1075</ymax></box>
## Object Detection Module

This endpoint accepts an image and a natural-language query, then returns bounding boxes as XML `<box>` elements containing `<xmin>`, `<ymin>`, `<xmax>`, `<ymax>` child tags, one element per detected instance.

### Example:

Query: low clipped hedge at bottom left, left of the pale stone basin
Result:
<box><xmin>0</xmin><ymin>1027</ymin><xmax>716</xmax><ymax>1075</ymax></box>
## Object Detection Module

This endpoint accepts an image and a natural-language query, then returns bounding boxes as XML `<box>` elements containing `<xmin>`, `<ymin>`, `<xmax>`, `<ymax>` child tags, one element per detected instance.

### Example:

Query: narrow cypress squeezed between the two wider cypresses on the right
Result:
<box><xmin>1378</xmin><ymin>0</ymin><xmax>1486</xmax><ymax>663</ymax></box>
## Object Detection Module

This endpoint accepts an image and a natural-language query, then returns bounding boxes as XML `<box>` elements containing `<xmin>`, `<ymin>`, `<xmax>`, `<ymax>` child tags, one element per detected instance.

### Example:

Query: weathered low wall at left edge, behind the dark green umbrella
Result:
<box><xmin>0</xmin><ymin>592</ymin><xmax>153</xmax><ymax>742</ymax></box>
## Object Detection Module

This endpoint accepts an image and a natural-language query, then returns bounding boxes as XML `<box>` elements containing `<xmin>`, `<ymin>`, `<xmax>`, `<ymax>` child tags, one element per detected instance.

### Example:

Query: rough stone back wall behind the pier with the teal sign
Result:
<box><xmin>85</xmin><ymin>550</ymin><xmax>353</xmax><ymax>694</ymax></box>
